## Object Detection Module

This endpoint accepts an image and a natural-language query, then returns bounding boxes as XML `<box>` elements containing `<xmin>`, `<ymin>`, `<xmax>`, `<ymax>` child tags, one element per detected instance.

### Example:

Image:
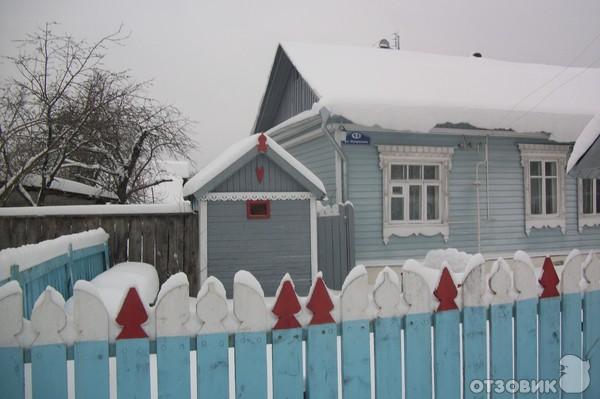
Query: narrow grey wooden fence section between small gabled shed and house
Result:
<box><xmin>317</xmin><ymin>203</ymin><xmax>355</xmax><ymax>290</ymax></box>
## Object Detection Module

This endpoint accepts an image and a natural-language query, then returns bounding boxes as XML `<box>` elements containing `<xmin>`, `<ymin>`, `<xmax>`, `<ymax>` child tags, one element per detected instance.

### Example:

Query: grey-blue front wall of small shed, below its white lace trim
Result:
<box><xmin>207</xmin><ymin>200</ymin><xmax>311</xmax><ymax>297</ymax></box>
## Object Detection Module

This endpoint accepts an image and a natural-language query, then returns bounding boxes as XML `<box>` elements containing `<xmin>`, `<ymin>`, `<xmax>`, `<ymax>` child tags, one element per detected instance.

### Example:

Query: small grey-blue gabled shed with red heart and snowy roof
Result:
<box><xmin>183</xmin><ymin>135</ymin><xmax>326</xmax><ymax>296</ymax></box>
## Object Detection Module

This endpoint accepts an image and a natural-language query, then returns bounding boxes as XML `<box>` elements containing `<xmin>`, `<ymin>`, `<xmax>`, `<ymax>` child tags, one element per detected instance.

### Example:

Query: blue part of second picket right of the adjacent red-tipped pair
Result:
<box><xmin>374</xmin><ymin>317</ymin><xmax>402</xmax><ymax>399</ymax></box>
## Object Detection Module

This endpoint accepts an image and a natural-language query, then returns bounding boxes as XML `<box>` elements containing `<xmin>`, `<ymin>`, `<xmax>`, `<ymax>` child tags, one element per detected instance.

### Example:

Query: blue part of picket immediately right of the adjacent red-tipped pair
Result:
<box><xmin>342</xmin><ymin>320</ymin><xmax>371</xmax><ymax>399</ymax></box>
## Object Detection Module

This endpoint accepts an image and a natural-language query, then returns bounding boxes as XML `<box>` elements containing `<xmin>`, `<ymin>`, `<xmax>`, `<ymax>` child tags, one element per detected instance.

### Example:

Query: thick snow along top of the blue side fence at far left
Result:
<box><xmin>0</xmin><ymin>228</ymin><xmax>108</xmax><ymax>281</ymax></box>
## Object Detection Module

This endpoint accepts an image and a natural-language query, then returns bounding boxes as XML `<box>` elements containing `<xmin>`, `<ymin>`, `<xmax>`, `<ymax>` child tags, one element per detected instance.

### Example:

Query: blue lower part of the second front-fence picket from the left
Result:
<box><xmin>31</xmin><ymin>344</ymin><xmax>67</xmax><ymax>399</ymax></box>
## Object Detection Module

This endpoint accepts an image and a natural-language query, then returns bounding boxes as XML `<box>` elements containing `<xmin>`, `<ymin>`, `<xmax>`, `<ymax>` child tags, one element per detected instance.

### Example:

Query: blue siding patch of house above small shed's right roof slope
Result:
<box><xmin>286</xmin><ymin>135</ymin><xmax>336</xmax><ymax>203</ymax></box>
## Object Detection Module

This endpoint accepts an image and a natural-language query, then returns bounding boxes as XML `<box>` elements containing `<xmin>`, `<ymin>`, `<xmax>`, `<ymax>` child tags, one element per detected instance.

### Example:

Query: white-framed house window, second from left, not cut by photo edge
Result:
<box><xmin>519</xmin><ymin>144</ymin><xmax>569</xmax><ymax>235</ymax></box>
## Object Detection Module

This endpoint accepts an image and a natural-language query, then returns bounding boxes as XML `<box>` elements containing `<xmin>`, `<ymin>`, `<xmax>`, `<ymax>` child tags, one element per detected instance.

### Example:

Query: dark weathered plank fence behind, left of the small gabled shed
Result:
<box><xmin>0</xmin><ymin>211</ymin><xmax>199</xmax><ymax>293</ymax></box>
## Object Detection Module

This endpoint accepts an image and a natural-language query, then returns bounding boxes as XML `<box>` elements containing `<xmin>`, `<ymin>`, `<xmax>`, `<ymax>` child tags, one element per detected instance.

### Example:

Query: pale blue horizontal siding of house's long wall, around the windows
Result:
<box><xmin>343</xmin><ymin>133</ymin><xmax>600</xmax><ymax>263</ymax></box>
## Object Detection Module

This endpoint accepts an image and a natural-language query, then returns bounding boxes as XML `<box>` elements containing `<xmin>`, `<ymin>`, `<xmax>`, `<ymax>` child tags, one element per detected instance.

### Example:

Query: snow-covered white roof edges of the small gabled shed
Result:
<box><xmin>183</xmin><ymin>134</ymin><xmax>326</xmax><ymax>198</ymax></box>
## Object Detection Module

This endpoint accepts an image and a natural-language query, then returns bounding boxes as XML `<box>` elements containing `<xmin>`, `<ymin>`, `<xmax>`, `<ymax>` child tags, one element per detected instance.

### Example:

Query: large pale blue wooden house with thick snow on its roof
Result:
<box><xmin>253</xmin><ymin>43</ymin><xmax>600</xmax><ymax>266</ymax></box>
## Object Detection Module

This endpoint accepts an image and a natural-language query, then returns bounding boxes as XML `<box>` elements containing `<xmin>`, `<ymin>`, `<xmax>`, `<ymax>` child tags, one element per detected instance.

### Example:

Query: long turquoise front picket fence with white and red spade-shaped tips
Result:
<box><xmin>0</xmin><ymin>253</ymin><xmax>600</xmax><ymax>399</ymax></box>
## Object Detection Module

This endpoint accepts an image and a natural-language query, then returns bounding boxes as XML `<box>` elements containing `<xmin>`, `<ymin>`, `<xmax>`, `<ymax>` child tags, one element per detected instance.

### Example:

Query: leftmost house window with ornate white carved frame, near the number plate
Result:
<box><xmin>378</xmin><ymin>145</ymin><xmax>453</xmax><ymax>243</ymax></box>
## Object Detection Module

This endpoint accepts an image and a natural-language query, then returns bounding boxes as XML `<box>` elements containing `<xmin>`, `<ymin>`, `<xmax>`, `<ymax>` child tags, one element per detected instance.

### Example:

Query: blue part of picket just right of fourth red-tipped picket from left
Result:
<box><xmin>463</xmin><ymin>306</ymin><xmax>487</xmax><ymax>399</ymax></box>
